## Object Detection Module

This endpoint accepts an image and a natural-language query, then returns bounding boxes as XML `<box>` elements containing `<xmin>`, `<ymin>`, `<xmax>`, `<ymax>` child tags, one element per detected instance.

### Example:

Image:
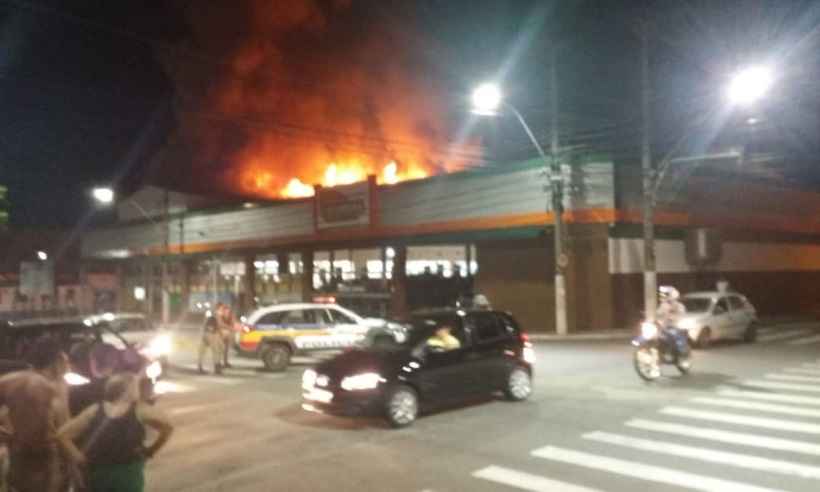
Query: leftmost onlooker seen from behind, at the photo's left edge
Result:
<box><xmin>0</xmin><ymin>337</ymin><xmax>77</xmax><ymax>492</ymax></box>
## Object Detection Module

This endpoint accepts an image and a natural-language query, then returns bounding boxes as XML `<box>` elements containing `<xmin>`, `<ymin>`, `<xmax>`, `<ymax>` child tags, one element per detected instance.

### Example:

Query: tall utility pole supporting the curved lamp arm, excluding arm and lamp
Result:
<box><xmin>549</xmin><ymin>46</ymin><xmax>568</xmax><ymax>335</ymax></box>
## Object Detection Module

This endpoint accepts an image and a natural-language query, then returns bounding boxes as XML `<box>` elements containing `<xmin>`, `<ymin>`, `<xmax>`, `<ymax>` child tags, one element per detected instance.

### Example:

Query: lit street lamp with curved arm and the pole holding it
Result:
<box><xmin>472</xmin><ymin>83</ymin><xmax>567</xmax><ymax>335</ymax></box>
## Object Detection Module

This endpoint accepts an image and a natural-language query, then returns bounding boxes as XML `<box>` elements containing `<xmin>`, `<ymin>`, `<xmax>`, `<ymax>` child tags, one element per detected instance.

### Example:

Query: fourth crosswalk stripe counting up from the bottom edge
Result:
<box><xmin>624</xmin><ymin>419</ymin><xmax>820</xmax><ymax>456</ymax></box>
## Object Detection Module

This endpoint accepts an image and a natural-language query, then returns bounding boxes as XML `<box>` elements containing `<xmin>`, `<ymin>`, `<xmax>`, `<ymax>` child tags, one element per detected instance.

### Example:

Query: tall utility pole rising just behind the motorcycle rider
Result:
<box><xmin>641</xmin><ymin>15</ymin><xmax>658</xmax><ymax>322</ymax></box>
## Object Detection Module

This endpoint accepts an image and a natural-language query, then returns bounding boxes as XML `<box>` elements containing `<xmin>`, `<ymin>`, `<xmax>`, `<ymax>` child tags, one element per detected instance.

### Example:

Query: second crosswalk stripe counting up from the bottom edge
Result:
<box><xmin>531</xmin><ymin>446</ymin><xmax>788</xmax><ymax>492</ymax></box>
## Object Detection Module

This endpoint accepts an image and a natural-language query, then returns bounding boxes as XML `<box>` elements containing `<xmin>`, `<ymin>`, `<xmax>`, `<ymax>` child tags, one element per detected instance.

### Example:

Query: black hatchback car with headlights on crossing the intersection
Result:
<box><xmin>302</xmin><ymin>309</ymin><xmax>535</xmax><ymax>427</ymax></box>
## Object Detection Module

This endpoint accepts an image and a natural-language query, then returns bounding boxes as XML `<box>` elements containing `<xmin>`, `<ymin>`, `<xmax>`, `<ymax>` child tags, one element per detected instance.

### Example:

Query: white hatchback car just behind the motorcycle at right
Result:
<box><xmin>677</xmin><ymin>291</ymin><xmax>757</xmax><ymax>348</ymax></box>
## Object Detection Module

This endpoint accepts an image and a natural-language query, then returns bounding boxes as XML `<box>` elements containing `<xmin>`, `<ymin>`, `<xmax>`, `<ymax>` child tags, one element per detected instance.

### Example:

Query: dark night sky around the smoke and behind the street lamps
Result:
<box><xmin>0</xmin><ymin>0</ymin><xmax>820</xmax><ymax>227</ymax></box>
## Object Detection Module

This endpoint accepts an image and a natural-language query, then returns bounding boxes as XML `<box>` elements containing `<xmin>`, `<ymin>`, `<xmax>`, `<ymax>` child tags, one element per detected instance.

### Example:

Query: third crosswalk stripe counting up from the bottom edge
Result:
<box><xmin>583</xmin><ymin>432</ymin><xmax>820</xmax><ymax>478</ymax></box>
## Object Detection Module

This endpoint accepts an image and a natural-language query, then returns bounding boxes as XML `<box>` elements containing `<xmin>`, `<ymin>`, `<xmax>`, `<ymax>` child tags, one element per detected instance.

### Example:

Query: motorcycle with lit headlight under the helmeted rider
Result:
<box><xmin>632</xmin><ymin>321</ymin><xmax>692</xmax><ymax>381</ymax></box>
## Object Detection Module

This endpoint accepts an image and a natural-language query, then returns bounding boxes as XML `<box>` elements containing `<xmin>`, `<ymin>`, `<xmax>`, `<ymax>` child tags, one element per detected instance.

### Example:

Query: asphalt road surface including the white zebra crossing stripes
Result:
<box><xmin>148</xmin><ymin>324</ymin><xmax>820</xmax><ymax>492</ymax></box>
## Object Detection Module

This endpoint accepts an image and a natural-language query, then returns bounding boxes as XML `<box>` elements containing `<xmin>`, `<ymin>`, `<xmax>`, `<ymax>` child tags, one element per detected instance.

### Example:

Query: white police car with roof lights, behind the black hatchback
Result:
<box><xmin>238</xmin><ymin>303</ymin><xmax>388</xmax><ymax>371</ymax></box>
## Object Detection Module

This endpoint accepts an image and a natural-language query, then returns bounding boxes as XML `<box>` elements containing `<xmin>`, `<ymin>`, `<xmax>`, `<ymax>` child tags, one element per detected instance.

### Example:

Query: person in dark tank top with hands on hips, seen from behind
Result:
<box><xmin>57</xmin><ymin>373</ymin><xmax>173</xmax><ymax>492</ymax></box>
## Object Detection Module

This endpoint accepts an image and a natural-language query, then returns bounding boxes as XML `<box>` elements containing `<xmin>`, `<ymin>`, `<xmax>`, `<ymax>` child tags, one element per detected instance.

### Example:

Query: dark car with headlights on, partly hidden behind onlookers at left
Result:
<box><xmin>0</xmin><ymin>316</ymin><xmax>162</xmax><ymax>414</ymax></box>
